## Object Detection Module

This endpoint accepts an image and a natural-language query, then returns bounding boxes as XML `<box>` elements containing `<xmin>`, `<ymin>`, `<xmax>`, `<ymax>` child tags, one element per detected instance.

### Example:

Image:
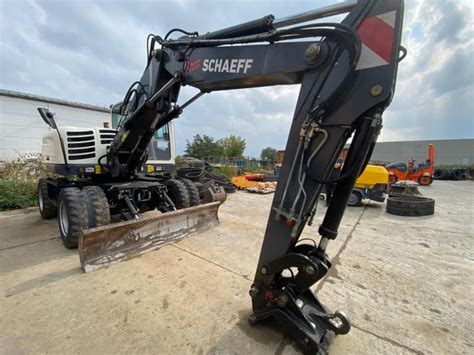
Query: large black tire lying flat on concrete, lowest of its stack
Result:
<box><xmin>387</xmin><ymin>196</ymin><xmax>435</xmax><ymax>217</ymax></box>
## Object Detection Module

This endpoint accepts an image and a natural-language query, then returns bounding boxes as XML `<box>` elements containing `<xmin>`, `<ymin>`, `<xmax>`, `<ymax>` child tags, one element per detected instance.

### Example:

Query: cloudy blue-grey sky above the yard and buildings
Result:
<box><xmin>0</xmin><ymin>0</ymin><xmax>474</xmax><ymax>156</ymax></box>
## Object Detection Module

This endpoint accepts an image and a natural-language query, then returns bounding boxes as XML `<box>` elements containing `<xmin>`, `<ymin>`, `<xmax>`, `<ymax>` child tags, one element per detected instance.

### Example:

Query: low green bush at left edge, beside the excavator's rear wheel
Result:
<box><xmin>0</xmin><ymin>179</ymin><xmax>38</xmax><ymax>211</ymax></box>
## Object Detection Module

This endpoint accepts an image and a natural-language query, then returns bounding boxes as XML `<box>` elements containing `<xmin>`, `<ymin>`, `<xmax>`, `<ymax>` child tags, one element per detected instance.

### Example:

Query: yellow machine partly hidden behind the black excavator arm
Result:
<box><xmin>347</xmin><ymin>165</ymin><xmax>388</xmax><ymax>206</ymax></box>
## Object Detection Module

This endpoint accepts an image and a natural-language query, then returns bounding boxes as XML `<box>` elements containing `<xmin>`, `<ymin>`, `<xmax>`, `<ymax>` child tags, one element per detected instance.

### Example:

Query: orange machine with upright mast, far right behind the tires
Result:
<box><xmin>385</xmin><ymin>144</ymin><xmax>434</xmax><ymax>185</ymax></box>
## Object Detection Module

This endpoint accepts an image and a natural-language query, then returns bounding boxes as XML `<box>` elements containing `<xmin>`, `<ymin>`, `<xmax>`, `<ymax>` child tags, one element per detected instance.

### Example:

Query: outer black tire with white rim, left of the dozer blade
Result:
<box><xmin>58</xmin><ymin>187</ymin><xmax>89</xmax><ymax>249</ymax></box>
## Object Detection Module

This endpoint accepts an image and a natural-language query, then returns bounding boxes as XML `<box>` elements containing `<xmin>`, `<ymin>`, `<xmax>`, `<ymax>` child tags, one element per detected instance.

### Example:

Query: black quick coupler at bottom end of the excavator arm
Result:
<box><xmin>249</xmin><ymin>253</ymin><xmax>351</xmax><ymax>354</ymax></box>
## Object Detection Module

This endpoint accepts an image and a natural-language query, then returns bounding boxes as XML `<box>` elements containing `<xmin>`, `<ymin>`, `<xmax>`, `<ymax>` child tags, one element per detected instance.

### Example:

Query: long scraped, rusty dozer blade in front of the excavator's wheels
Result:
<box><xmin>79</xmin><ymin>202</ymin><xmax>220</xmax><ymax>272</ymax></box>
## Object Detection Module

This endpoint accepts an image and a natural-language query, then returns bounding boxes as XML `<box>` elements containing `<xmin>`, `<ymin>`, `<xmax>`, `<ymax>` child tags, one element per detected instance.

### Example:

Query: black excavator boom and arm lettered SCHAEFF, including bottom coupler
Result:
<box><xmin>88</xmin><ymin>0</ymin><xmax>405</xmax><ymax>353</ymax></box>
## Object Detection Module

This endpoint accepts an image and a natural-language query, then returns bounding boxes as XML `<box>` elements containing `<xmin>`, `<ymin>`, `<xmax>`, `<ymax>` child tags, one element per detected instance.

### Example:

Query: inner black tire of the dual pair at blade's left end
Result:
<box><xmin>81</xmin><ymin>186</ymin><xmax>110</xmax><ymax>228</ymax></box>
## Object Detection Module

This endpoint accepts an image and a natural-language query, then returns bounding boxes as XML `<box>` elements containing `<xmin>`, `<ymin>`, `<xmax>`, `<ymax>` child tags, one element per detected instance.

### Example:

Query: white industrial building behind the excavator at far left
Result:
<box><xmin>0</xmin><ymin>89</ymin><xmax>111</xmax><ymax>161</ymax></box>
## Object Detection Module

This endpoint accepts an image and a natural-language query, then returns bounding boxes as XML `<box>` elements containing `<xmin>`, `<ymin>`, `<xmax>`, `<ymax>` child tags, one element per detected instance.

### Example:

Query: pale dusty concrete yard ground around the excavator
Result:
<box><xmin>0</xmin><ymin>181</ymin><xmax>474</xmax><ymax>354</ymax></box>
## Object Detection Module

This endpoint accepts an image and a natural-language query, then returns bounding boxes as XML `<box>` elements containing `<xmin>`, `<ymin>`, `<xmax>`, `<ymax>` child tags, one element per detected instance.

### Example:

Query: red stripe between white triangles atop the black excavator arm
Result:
<box><xmin>357</xmin><ymin>16</ymin><xmax>395</xmax><ymax>63</ymax></box>
